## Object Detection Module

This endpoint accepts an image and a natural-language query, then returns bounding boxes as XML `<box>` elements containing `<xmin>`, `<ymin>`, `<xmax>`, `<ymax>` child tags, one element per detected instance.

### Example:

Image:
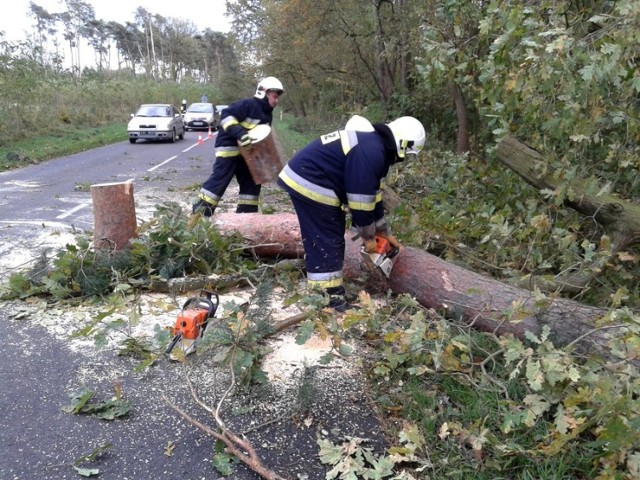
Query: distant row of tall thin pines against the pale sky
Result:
<box><xmin>9</xmin><ymin>0</ymin><xmax>239</xmax><ymax>84</ymax></box>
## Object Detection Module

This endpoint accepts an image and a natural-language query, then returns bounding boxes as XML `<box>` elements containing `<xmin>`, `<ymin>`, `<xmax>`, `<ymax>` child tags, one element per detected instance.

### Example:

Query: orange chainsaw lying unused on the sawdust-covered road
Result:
<box><xmin>166</xmin><ymin>290</ymin><xmax>220</xmax><ymax>360</ymax></box>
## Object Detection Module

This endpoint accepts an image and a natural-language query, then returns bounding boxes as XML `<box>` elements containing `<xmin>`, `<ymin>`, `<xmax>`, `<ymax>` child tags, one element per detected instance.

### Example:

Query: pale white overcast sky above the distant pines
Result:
<box><xmin>0</xmin><ymin>0</ymin><xmax>230</xmax><ymax>41</ymax></box>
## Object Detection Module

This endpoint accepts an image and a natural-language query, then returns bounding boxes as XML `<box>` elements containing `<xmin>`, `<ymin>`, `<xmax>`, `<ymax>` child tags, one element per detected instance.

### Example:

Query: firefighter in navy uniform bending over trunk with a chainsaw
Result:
<box><xmin>278</xmin><ymin>116</ymin><xmax>425</xmax><ymax>311</ymax></box>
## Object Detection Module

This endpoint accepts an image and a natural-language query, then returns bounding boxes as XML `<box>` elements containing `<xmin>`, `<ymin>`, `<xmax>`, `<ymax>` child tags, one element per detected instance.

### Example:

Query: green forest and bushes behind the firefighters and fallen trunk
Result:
<box><xmin>0</xmin><ymin>0</ymin><xmax>640</xmax><ymax>479</ymax></box>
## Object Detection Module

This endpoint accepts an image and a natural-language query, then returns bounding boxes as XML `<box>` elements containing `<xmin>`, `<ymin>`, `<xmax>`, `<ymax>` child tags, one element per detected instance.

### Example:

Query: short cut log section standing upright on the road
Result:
<box><xmin>91</xmin><ymin>182</ymin><xmax>137</xmax><ymax>250</ymax></box>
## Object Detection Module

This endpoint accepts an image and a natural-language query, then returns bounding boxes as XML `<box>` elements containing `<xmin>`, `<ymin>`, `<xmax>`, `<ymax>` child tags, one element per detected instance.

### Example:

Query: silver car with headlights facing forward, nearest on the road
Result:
<box><xmin>127</xmin><ymin>103</ymin><xmax>184</xmax><ymax>143</ymax></box>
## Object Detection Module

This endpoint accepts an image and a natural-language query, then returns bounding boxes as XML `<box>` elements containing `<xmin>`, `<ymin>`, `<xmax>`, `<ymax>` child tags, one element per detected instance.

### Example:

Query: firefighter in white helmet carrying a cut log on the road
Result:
<box><xmin>192</xmin><ymin>77</ymin><xmax>284</xmax><ymax>217</ymax></box>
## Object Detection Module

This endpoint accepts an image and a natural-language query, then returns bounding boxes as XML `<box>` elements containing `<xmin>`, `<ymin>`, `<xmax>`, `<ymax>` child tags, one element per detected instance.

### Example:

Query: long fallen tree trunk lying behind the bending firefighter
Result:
<box><xmin>215</xmin><ymin>213</ymin><xmax>632</xmax><ymax>356</ymax></box>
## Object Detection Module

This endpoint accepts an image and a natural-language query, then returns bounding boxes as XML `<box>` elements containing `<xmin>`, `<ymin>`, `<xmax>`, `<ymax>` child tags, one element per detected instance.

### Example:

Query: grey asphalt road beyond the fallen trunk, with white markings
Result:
<box><xmin>0</xmin><ymin>132</ymin><xmax>215</xmax><ymax>240</ymax></box>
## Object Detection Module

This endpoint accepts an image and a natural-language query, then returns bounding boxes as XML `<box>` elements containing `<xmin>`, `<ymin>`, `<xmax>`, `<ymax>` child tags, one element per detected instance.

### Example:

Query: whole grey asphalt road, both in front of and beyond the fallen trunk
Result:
<box><xmin>0</xmin><ymin>136</ymin><xmax>384</xmax><ymax>480</ymax></box>
